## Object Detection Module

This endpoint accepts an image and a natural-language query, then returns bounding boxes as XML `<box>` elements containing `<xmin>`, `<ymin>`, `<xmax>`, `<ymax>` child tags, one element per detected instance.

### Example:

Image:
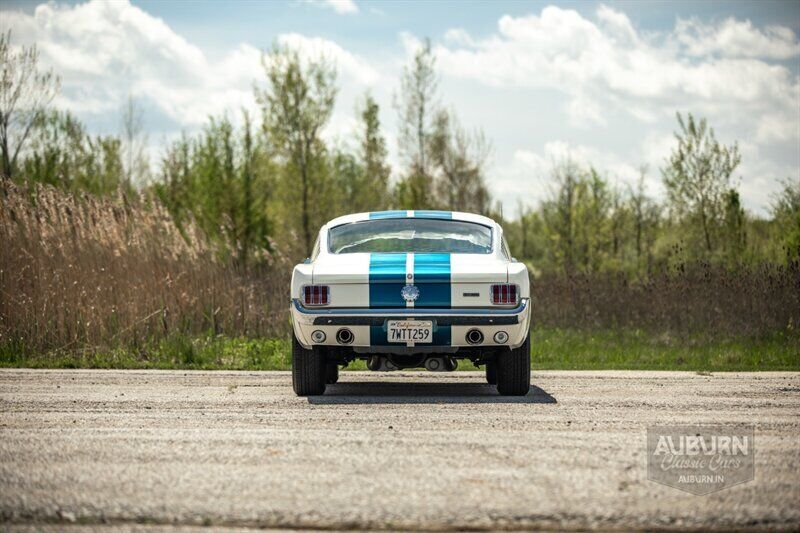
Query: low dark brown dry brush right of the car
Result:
<box><xmin>532</xmin><ymin>262</ymin><xmax>800</xmax><ymax>338</ymax></box>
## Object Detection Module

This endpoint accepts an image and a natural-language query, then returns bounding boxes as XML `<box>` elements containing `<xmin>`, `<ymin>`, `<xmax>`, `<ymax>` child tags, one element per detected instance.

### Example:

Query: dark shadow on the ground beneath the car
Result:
<box><xmin>308</xmin><ymin>381</ymin><xmax>558</xmax><ymax>405</ymax></box>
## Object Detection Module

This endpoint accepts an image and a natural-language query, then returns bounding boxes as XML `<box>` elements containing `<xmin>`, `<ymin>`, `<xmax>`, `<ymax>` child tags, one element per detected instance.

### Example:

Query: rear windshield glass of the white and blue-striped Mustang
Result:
<box><xmin>328</xmin><ymin>218</ymin><xmax>492</xmax><ymax>254</ymax></box>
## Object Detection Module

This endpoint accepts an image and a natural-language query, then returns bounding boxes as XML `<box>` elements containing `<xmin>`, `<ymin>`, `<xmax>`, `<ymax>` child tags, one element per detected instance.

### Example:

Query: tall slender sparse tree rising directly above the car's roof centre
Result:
<box><xmin>395</xmin><ymin>39</ymin><xmax>439</xmax><ymax>209</ymax></box>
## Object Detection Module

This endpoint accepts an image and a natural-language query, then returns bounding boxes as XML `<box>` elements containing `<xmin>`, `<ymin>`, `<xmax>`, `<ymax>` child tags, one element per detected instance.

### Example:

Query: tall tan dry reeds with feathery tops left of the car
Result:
<box><xmin>0</xmin><ymin>182</ymin><xmax>290</xmax><ymax>351</ymax></box>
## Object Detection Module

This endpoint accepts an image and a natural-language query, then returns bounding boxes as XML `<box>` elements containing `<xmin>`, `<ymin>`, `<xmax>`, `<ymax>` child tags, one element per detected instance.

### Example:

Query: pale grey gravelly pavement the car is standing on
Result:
<box><xmin>0</xmin><ymin>370</ymin><xmax>800</xmax><ymax>529</ymax></box>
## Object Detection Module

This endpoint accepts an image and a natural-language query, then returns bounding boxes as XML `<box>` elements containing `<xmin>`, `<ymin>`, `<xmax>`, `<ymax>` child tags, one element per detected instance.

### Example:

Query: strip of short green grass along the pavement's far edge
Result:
<box><xmin>0</xmin><ymin>328</ymin><xmax>800</xmax><ymax>372</ymax></box>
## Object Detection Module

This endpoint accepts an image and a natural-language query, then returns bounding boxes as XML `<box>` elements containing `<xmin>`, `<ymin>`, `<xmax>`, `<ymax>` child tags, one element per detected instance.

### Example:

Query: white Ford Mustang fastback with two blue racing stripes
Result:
<box><xmin>291</xmin><ymin>211</ymin><xmax>530</xmax><ymax>396</ymax></box>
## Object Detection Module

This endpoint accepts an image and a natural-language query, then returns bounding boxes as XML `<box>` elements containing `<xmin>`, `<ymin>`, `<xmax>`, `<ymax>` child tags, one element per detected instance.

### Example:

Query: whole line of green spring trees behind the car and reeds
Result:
<box><xmin>0</xmin><ymin>33</ymin><xmax>800</xmax><ymax>276</ymax></box>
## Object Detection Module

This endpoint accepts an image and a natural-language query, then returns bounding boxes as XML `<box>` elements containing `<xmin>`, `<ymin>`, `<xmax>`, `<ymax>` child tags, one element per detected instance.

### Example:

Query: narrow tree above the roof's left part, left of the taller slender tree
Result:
<box><xmin>360</xmin><ymin>94</ymin><xmax>391</xmax><ymax>210</ymax></box>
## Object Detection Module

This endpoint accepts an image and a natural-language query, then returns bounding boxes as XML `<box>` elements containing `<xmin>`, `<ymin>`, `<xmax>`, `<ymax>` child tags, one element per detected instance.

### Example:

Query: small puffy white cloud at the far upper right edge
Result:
<box><xmin>675</xmin><ymin>18</ymin><xmax>800</xmax><ymax>59</ymax></box>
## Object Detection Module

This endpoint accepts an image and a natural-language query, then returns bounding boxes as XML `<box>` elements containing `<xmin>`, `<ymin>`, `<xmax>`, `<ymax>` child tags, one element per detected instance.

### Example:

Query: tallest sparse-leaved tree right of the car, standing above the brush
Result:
<box><xmin>662</xmin><ymin>113</ymin><xmax>741</xmax><ymax>256</ymax></box>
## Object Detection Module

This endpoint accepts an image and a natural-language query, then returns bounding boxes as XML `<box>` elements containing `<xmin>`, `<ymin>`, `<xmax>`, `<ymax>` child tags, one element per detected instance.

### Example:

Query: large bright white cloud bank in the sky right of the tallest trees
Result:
<box><xmin>435</xmin><ymin>5</ymin><xmax>800</xmax><ymax>132</ymax></box>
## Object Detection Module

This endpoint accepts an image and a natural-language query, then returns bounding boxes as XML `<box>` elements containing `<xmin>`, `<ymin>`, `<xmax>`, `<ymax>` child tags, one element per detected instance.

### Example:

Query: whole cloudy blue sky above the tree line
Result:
<box><xmin>0</xmin><ymin>0</ymin><xmax>800</xmax><ymax>214</ymax></box>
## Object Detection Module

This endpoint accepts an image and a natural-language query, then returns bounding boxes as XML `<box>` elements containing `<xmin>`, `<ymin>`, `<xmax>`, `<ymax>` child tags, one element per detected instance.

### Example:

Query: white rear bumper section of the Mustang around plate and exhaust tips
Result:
<box><xmin>291</xmin><ymin>298</ymin><xmax>530</xmax><ymax>353</ymax></box>
